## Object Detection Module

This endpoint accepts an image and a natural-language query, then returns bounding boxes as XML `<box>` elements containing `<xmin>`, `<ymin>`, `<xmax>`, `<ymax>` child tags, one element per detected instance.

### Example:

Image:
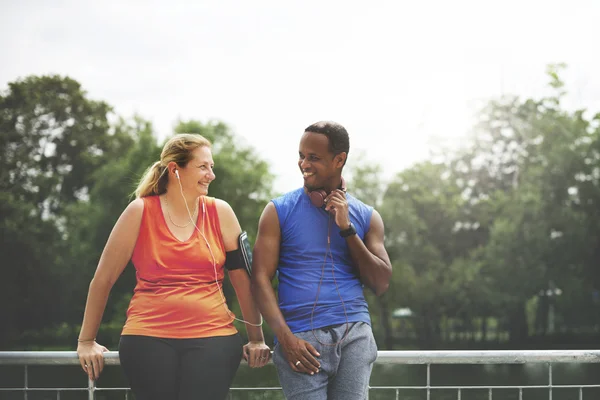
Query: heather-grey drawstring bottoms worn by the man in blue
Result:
<box><xmin>273</xmin><ymin>322</ymin><xmax>377</xmax><ymax>400</ymax></box>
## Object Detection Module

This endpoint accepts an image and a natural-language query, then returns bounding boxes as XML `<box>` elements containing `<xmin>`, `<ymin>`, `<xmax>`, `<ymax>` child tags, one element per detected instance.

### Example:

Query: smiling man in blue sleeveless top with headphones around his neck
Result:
<box><xmin>252</xmin><ymin>122</ymin><xmax>392</xmax><ymax>400</ymax></box>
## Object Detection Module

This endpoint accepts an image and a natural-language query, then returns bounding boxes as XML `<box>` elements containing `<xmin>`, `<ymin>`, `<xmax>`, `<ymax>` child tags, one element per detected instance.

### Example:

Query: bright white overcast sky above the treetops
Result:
<box><xmin>0</xmin><ymin>0</ymin><xmax>600</xmax><ymax>191</ymax></box>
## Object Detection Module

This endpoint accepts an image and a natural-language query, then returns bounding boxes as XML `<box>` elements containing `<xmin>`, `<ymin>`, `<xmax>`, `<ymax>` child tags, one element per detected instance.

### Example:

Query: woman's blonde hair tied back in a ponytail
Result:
<box><xmin>134</xmin><ymin>133</ymin><xmax>211</xmax><ymax>198</ymax></box>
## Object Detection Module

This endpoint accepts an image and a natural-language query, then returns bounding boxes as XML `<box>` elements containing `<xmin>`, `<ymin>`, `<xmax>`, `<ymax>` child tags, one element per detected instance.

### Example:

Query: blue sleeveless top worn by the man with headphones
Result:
<box><xmin>272</xmin><ymin>188</ymin><xmax>373</xmax><ymax>333</ymax></box>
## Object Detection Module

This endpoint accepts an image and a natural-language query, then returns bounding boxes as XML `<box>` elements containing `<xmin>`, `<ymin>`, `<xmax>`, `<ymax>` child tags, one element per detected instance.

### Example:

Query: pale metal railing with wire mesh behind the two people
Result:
<box><xmin>0</xmin><ymin>350</ymin><xmax>600</xmax><ymax>400</ymax></box>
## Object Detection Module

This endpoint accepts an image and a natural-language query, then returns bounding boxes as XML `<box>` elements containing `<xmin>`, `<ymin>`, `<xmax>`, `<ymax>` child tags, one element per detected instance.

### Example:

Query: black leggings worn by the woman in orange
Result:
<box><xmin>119</xmin><ymin>334</ymin><xmax>243</xmax><ymax>400</ymax></box>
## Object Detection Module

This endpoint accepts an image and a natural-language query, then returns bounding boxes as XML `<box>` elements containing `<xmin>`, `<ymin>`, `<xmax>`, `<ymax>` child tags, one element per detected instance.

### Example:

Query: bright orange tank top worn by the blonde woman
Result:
<box><xmin>122</xmin><ymin>196</ymin><xmax>237</xmax><ymax>339</ymax></box>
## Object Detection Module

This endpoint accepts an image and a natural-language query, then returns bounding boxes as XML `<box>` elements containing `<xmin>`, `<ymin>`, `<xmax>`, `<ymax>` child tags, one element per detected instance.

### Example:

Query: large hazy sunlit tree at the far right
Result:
<box><xmin>448</xmin><ymin>65</ymin><xmax>598</xmax><ymax>341</ymax></box>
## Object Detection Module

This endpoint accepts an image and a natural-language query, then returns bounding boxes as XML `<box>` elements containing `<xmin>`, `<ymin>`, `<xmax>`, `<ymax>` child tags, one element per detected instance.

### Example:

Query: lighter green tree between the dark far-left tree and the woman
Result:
<box><xmin>65</xmin><ymin>116</ymin><xmax>162</xmax><ymax>332</ymax></box>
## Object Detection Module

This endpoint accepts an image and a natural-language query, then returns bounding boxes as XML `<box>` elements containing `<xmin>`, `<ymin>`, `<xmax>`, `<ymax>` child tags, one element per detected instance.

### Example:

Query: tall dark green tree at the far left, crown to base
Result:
<box><xmin>0</xmin><ymin>76</ymin><xmax>118</xmax><ymax>347</ymax></box>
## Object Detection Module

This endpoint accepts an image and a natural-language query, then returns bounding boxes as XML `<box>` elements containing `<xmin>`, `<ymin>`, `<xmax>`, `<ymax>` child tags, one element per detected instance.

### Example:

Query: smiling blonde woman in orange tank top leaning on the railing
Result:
<box><xmin>77</xmin><ymin>134</ymin><xmax>270</xmax><ymax>400</ymax></box>
